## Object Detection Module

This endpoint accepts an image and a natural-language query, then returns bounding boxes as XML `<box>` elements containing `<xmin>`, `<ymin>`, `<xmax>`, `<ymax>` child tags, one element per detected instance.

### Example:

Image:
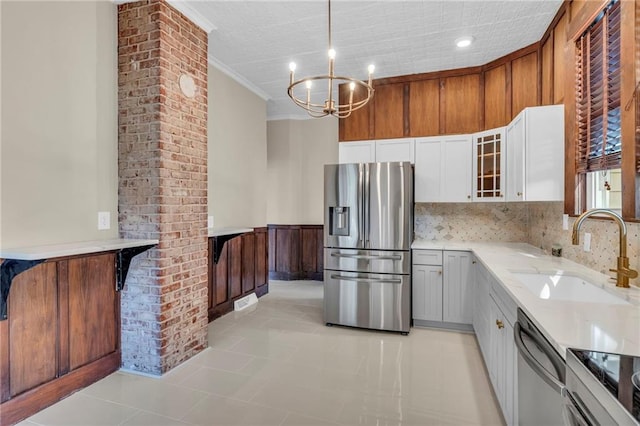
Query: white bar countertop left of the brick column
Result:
<box><xmin>0</xmin><ymin>238</ymin><xmax>158</xmax><ymax>260</ymax></box>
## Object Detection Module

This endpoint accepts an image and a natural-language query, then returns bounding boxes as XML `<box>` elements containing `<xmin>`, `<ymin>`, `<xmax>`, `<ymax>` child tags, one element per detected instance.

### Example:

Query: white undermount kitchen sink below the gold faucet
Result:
<box><xmin>512</xmin><ymin>272</ymin><xmax>630</xmax><ymax>305</ymax></box>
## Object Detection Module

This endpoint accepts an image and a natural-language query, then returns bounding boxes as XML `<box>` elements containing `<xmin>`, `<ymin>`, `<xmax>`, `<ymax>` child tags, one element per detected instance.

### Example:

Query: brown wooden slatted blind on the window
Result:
<box><xmin>576</xmin><ymin>0</ymin><xmax>622</xmax><ymax>173</ymax></box>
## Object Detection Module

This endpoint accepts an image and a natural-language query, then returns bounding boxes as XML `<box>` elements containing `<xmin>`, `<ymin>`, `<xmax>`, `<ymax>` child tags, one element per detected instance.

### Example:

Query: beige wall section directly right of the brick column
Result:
<box><xmin>208</xmin><ymin>65</ymin><xmax>267</xmax><ymax>227</ymax></box>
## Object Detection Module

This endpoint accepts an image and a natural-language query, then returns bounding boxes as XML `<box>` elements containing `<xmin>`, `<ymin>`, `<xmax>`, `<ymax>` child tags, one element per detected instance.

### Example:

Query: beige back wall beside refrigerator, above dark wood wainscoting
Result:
<box><xmin>267</xmin><ymin>117</ymin><xmax>338</xmax><ymax>225</ymax></box>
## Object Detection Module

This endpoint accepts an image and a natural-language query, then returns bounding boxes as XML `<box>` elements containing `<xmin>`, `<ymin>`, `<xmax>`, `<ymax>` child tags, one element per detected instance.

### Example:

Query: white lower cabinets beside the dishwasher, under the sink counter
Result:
<box><xmin>473</xmin><ymin>265</ymin><xmax>518</xmax><ymax>425</ymax></box>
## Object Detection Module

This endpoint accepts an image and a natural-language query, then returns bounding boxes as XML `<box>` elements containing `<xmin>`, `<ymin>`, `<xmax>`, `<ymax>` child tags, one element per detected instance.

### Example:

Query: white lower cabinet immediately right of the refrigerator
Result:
<box><xmin>412</xmin><ymin>250</ymin><xmax>475</xmax><ymax>329</ymax></box>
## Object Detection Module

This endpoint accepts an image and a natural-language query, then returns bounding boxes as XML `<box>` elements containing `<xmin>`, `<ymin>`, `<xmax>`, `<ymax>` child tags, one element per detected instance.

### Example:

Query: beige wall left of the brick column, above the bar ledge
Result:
<box><xmin>0</xmin><ymin>1</ymin><xmax>118</xmax><ymax>248</ymax></box>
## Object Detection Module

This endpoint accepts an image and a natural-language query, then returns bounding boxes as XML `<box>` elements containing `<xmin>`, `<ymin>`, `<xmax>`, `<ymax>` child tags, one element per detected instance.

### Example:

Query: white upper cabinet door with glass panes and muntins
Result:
<box><xmin>473</xmin><ymin>127</ymin><xmax>506</xmax><ymax>201</ymax></box>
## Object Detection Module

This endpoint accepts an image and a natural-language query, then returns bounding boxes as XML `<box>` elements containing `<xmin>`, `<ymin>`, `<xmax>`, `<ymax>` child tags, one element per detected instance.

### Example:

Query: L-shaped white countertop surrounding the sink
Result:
<box><xmin>411</xmin><ymin>241</ymin><xmax>640</xmax><ymax>357</ymax></box>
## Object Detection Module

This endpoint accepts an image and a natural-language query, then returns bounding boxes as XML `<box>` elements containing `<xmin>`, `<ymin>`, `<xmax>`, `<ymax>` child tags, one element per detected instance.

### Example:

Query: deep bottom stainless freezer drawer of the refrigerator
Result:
<box><xmin>324</xmin><ymin>270</ymin><xmax>411</xmax><ymax>333</ymax></box>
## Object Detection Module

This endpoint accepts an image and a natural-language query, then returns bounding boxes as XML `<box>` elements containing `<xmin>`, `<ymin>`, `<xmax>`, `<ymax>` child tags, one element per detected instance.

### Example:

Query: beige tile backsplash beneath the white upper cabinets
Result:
<box><xmin>415</xmin><ymin>202</ymin><xmax>640</xmax><ymax>285</ymax></box>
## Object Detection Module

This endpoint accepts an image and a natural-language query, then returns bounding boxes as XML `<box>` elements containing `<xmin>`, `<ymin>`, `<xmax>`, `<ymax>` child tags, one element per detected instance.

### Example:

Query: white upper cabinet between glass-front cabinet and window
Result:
<box><xmin>506</xmin><ymin>105</ymin><xmax>564</xmax><ymax>201</ymax></box>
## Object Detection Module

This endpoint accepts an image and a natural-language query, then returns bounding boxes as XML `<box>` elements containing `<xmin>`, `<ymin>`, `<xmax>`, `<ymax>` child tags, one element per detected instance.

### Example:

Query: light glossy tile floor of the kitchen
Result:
<box><xmin>21</xmin><ymin>281</ymin><xmax>503</xmax><ymax>426</ymax></box>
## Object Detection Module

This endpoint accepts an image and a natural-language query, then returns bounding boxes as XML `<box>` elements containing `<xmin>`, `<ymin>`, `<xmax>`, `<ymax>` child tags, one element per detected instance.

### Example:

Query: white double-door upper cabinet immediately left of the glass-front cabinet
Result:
<box><xmin>414</xmin><ymin>135</ymin><xmax>472</xmax><ymax>203</ymax></box>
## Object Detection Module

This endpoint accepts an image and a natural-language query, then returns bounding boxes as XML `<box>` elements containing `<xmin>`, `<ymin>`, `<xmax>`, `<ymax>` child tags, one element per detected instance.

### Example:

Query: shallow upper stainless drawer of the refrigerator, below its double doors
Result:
<box><xmin>324</xmin><ymin>248</ymin><xmax>411</xmax><ymax>274</ymax></box>
